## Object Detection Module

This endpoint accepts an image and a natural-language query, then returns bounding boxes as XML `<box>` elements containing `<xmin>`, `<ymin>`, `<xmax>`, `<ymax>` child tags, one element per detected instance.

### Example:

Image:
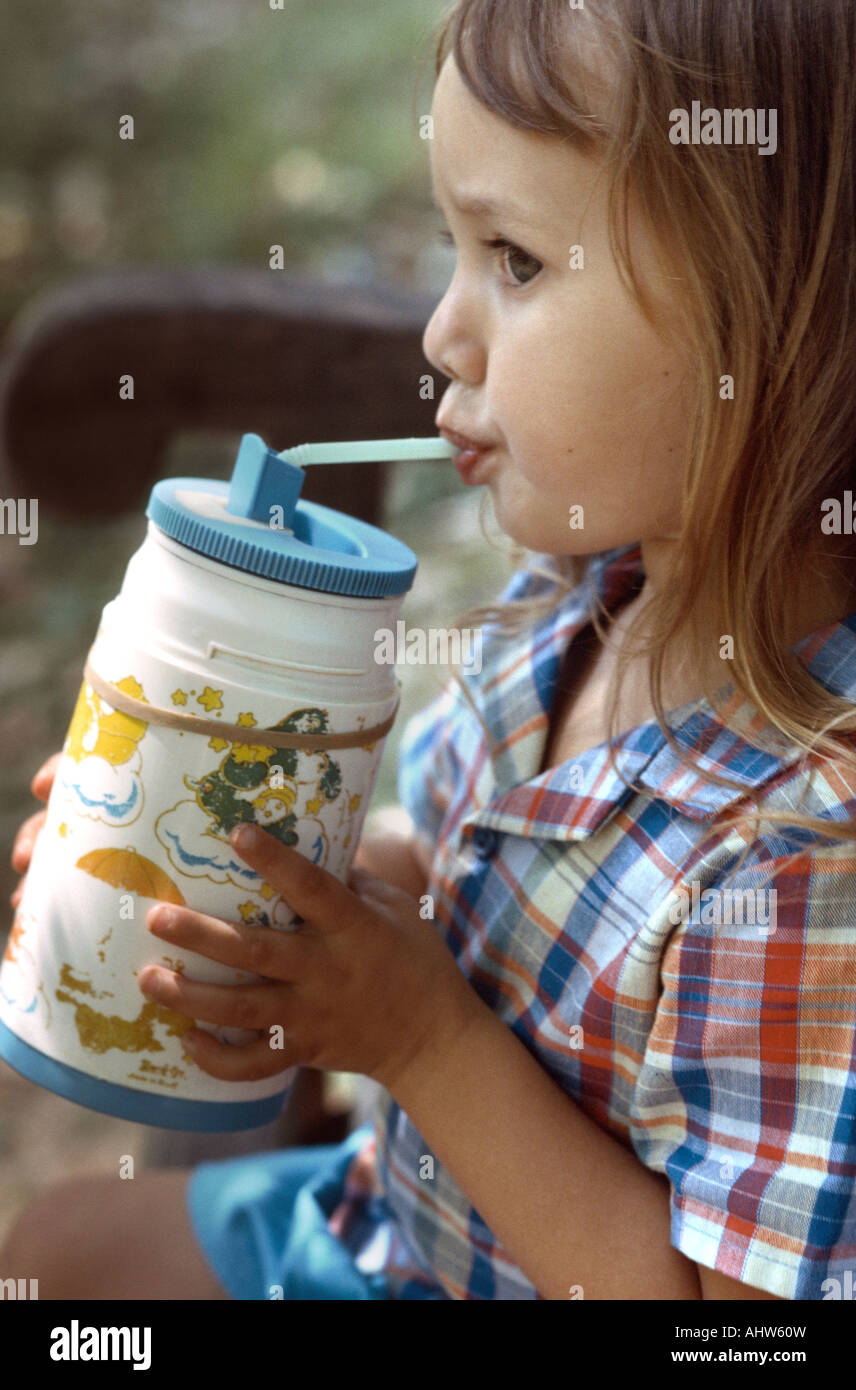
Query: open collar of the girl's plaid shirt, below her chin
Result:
<box><xmin>464</xmin><ymin>543</ymin><xmax>856</xmax><ymax>840</ymax></box>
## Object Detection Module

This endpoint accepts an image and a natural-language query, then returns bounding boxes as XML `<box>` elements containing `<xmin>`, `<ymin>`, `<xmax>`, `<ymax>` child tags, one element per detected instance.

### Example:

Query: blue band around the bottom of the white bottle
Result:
<box><xmin>0</xmin><ymin>1022</ymin><xmax>285</xmax><ymax>1134</ymax></box>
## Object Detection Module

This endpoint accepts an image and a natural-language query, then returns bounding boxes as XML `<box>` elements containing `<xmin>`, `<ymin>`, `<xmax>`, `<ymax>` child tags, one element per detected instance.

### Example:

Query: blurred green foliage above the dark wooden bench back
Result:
<box><xmin>0</xmin><ymin>0</ymin><xmax>458</xmax><ymax>322</ymax></box>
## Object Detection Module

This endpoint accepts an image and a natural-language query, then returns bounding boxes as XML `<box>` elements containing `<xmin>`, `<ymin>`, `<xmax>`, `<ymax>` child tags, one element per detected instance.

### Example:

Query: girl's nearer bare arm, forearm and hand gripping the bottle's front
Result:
<box><xmin>139</xmin><ymin>824</ymin><xmax>789</xmax><ymax>1300</ymax></box>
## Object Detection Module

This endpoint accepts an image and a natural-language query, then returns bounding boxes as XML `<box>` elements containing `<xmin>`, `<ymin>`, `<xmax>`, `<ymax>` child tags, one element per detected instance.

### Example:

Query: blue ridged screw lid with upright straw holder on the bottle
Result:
<box><xmin>146</xmin><ymin>434</ymin><xmax>418</xmax><ymax>598</ymax></box>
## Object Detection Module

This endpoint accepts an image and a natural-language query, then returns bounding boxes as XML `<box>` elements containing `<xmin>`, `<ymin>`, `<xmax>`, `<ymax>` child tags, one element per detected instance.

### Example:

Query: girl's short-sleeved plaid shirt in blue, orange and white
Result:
<box><xmin>331</xmin><ymin>545</ymin><xmax>856</xmax><ymax>1300</ymax></box>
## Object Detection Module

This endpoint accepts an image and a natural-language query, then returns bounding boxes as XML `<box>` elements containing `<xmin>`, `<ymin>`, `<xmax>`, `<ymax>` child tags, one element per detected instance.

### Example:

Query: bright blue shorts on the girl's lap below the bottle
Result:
<box><xmin>188</xmin><ymin>1125</ymin><xmax>390</xmax><ymax>1300</ymax></box>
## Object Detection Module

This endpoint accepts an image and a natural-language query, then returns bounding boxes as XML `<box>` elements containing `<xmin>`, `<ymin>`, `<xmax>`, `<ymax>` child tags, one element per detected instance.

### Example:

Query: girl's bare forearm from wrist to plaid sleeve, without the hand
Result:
<box><xmin>389</xmin><ymin>1006</ymin><xmax>717</xmax><ymax>1300</ymax></box>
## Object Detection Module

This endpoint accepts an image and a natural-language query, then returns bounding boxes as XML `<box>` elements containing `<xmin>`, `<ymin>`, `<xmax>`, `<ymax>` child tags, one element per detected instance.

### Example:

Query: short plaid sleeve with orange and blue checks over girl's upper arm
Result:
<box><xmin>631</xmin><ymin>840</ymin><xmax>856</xmax><ymax>1300</ymax></box>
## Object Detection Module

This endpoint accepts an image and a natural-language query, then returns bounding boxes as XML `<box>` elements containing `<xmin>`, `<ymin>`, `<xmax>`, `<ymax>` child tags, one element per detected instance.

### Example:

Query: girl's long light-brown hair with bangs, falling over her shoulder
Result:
<box><xmin>414</xmin><ymin>0</ymin><xmax>856</xmax><ymax>900</ymax></box>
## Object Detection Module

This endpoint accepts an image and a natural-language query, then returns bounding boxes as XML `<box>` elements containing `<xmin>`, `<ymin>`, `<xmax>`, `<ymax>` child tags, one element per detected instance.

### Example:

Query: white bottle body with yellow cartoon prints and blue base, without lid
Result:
<box><xmin>0</xmin><ymin>524</ymin><xmax>403</xmax><ymax>1129</ymax></box>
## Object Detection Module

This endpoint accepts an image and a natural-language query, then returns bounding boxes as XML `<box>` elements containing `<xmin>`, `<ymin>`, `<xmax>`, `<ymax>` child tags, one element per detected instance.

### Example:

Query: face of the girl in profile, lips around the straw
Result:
<box><xmin>424</xmin><ymin>56</ymin><xmax>691</xmax><ymax>564</ymax></box>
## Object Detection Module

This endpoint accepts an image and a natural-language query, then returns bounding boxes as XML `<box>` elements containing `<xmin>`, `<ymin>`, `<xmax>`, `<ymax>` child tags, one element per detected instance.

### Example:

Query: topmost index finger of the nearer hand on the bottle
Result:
<box><xmin>229</xmin><ymin>821</ymin><xmax>360</xmax><ymax>930</ymax></box>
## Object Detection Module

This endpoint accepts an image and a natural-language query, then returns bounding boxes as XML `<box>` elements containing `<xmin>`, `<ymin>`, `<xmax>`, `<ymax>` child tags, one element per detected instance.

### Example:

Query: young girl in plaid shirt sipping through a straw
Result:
<box><xmin>0</xmin><ymin>0</ymin><xmax>856</xmax><ymax>1300</ymax></box>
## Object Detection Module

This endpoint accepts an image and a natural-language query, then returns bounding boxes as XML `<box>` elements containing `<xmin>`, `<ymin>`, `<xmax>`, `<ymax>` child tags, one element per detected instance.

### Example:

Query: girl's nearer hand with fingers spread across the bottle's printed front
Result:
<box><xmin>138</xmin><ymin>826</ymin><xmax>485</xmax><ymax>1091</ymax></box>
